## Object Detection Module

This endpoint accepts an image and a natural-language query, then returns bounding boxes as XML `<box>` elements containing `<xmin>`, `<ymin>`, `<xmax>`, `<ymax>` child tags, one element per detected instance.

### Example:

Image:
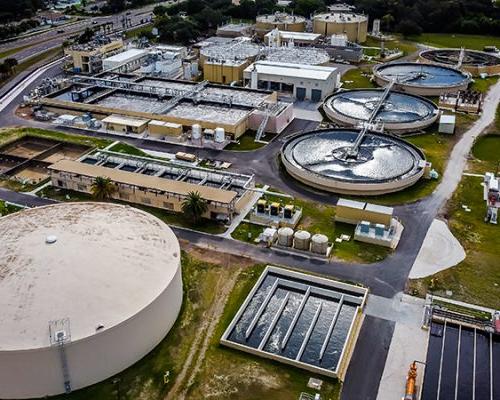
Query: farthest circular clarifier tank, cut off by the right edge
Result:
<box><xmin>420</xmin><ymin>49</ymin><xmax>500</xmax><ymax>76</ymax></box>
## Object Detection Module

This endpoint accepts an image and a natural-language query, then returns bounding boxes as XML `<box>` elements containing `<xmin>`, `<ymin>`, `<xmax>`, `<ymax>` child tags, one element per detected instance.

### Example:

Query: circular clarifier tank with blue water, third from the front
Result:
<box><xmin>373</xmin><ymin>63</ymin><xmax>470</xmax><ymax>96</ymax></box>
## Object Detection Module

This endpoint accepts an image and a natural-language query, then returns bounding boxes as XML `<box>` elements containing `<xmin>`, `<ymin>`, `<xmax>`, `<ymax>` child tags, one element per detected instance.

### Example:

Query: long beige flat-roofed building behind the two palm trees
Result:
<box><xmin>49</xmin><ymin>160</ymin><xmax>253</xmax><ymax>219</ymax></box>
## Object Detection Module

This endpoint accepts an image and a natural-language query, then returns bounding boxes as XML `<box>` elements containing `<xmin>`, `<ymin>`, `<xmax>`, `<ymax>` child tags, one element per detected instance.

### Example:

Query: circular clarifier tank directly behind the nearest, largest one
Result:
<box><xmin>323</xmin><ymin>89</ymin><xmax>439</xmax><ymax>132</ymax></box>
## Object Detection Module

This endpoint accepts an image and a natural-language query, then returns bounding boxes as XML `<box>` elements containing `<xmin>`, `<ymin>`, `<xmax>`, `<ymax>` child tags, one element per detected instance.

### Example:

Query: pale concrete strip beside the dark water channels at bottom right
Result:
<box><xmin>377</xmin><ymin>324</ymin><xmax>428</xmax><ymax>400</ymax></box>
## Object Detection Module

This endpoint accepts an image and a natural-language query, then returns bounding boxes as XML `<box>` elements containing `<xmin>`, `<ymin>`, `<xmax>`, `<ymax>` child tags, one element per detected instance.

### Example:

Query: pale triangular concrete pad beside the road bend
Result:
<box><xmin>409</xmin><ymin>219</ymin><xmax>466</xmax><ymax>279</ymax></box>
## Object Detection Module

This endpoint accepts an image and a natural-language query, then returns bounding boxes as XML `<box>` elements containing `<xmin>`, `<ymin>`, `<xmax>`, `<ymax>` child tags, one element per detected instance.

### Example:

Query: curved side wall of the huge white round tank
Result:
<box><xmin>0</xmin><ymin>262</ymin><xmax>182</xmax><ymax>399</ymax></box>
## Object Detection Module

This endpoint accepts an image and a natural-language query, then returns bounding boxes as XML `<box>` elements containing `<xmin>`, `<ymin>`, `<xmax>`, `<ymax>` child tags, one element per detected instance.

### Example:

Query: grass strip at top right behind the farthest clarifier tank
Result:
<box><xmin>409</xmin><ymin>33</ymin><xmax>500</xmax><ymax>50</ymax></box>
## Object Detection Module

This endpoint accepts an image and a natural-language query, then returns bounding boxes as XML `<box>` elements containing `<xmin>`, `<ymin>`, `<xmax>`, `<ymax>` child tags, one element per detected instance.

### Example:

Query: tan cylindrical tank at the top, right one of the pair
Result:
<box><xmin>313</xmin><ymin>11</ymin><xmax>368</xmax><ymax>43</ymax></box>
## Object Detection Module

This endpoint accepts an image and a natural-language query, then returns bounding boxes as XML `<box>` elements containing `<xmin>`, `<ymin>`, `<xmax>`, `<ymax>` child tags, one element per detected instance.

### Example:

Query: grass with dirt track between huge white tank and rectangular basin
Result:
<box><xmin>47</xmin><ymin>252</ymin><xmax>340</xmax><ymax>400</ymax></box>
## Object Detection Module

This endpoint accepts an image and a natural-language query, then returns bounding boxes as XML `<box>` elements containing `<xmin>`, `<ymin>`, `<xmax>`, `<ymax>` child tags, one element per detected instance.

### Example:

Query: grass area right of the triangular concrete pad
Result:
<box><xmin>408</xmin><ymin>176</ymin><xmax>500</xmax><ymax>309</ymax></box>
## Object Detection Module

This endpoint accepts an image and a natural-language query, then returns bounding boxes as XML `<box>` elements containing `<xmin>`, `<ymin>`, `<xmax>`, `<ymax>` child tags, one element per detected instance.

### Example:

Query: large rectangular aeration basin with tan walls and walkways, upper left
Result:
<box><xmin>36</xmin><ymin>75</ymin><xmax>293</xmax><ymax>141</ymax></box>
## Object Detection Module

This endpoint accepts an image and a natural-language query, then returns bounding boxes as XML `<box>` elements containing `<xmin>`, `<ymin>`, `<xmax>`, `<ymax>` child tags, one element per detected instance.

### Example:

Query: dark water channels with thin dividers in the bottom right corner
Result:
<box><xmin>422</xmin><ymin>322</ymin><xmax>500</xmax><ymax>400</ymax></box>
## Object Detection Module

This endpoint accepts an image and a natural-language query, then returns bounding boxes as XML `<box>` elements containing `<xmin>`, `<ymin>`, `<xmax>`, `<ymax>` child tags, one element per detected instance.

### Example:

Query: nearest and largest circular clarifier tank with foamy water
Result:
<box><xmin>281</xmin><ymin>129</ymin><xmax>425</xmax><ymax>195</ymax></box>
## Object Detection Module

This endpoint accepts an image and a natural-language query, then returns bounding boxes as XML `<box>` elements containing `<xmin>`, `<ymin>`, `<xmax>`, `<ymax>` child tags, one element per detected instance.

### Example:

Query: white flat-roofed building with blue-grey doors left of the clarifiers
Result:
<box><xmin>244</xmin><ymin>61</ymin><xmax>340</xmax><ymax>102</ymax></box>
